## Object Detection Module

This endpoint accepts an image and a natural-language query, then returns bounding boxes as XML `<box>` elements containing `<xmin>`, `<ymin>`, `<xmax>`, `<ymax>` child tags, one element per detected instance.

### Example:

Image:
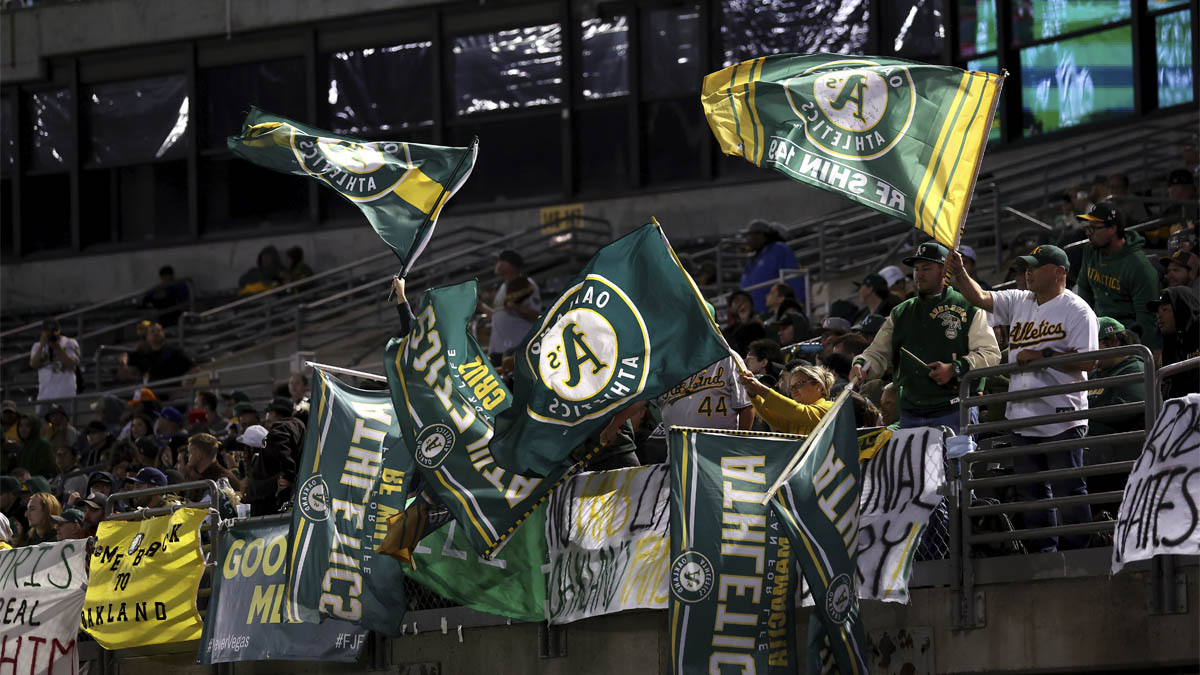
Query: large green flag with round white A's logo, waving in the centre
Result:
<box><xmin>491</xmin><ymin>222</ymin><xmax>730</xmax><ymax>476</ymax></box>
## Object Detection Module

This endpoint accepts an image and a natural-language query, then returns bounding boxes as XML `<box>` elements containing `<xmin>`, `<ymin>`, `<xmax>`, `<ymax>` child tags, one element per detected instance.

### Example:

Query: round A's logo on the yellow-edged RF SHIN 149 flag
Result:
<box><xmin>785</xmin><ymin>59</ymin><xmax>917</xmax><ymax>160</ymax></box>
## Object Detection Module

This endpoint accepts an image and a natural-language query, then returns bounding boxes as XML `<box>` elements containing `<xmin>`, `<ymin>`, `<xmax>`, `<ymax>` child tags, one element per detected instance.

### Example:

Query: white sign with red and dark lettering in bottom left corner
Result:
<box><xmin>0</xmin><ymin>539</ymin><xmax>88</xmax><ymax>675</ymax></box>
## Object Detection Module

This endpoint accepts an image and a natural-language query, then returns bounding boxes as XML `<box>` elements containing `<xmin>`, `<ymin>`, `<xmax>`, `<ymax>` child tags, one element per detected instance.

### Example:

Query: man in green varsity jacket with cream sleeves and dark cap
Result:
<box><xmin>850</xmin><ymin>241</ymin><xmax>1000</xmax><ymax>432</ymax></box>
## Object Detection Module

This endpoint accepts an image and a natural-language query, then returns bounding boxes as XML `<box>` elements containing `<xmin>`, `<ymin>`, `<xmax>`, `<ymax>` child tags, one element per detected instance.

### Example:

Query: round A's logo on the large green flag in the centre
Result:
<box><xmin>526</xmin><ymin>274</ymin><xmax>650</xmax><ymax>426</ymax></box>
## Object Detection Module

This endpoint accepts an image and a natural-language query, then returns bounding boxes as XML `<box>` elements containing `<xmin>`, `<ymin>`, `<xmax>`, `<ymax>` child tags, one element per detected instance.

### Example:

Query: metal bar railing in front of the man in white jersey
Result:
<box><xmin>947</xmin><ymin>345</ymin><xmax>1159</xmax><ymax>628</ymax></box>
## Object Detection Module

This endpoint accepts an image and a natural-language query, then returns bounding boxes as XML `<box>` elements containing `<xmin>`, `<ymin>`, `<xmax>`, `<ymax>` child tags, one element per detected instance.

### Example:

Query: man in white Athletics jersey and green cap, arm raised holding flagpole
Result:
<box><xmin>946</xmin><ymin>245</ymin><xmax>1098</xmax><ymax>552</ymax></box>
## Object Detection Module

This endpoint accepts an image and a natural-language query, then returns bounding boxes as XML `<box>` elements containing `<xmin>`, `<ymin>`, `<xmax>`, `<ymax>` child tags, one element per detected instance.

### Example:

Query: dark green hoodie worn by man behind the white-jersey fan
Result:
<box><xmin>1078</xmin><ymin>232</ymin><xmax>1163</xmax><ymax>350</ymax></box>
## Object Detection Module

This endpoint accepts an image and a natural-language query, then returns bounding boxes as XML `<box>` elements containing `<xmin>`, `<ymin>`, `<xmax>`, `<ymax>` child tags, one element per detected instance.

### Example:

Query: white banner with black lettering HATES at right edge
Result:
<box><xmin>1112</xmin><ymin>394</ymin><xmax>1200</xmax><ymax>573</ymax></box>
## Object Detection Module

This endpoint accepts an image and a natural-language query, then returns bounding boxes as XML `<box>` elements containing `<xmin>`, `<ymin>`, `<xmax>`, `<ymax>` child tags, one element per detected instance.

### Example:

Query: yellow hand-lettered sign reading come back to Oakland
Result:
<box><xmin>82</xmin><ymin>508</ymin><xmax>208</xmax><ymax>650</ymax></box>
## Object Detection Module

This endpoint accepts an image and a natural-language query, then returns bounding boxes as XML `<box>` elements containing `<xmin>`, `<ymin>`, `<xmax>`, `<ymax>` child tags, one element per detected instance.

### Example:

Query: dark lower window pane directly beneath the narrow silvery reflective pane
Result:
<box><xmin>574</xmin><ymin>106</ymin><xmax>630</xmax><ymax>191</ymax></box>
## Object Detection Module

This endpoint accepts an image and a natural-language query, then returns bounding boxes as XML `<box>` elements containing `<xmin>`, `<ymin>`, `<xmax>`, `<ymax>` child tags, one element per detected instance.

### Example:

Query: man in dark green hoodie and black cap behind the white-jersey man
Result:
<box><xmin>1076</xmin><ymin>202</ymin><xmax>1163</xmax><ymax>351</ymax></box>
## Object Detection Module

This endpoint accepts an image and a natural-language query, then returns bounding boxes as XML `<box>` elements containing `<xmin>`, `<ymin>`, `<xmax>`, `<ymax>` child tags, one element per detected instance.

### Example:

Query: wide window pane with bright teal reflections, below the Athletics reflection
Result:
<box><xmin>1021</xmin><ymin>26</ymin><xmax>1133</xmax><ymax>136</ymax></box>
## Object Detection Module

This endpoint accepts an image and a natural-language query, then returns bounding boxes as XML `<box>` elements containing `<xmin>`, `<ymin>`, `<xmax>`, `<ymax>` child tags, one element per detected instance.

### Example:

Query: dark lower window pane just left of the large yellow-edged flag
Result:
<box><xmin>642</xmin><ymin>96</ymin><xmax>710</xmax><ymax>185</ymax></box>
